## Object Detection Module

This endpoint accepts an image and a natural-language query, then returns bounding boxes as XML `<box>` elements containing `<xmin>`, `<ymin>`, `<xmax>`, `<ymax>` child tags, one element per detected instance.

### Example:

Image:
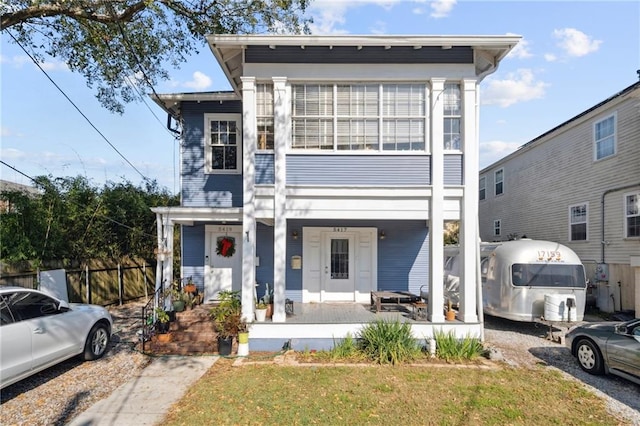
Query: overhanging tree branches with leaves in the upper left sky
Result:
<box><xmin>0</xmin><ymin>0</ymin><xmax>310</xmax><ymax>113</ymax></box>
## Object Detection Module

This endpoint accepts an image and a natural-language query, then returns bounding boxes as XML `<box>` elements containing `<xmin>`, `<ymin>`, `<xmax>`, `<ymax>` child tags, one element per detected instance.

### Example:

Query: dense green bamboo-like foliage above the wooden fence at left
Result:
<box><xmin>0</xmin><ymin>176</ymin><xmax>179</xmax><ymax>262</ymax></box>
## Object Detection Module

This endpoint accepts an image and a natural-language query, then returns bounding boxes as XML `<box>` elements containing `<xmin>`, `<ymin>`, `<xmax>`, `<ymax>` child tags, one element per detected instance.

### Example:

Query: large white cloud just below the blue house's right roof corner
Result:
<box><xmin>481</xmin><ymin>69</ymin><xmax>549</xmax><ymax>108</ymax></box>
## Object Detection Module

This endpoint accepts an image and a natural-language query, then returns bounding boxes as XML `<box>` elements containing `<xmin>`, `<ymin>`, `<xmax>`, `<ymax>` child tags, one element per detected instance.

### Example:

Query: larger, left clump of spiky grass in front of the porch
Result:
<box><xmin>358</xmin><ymin>320</ymin><xmax>422</xmax><ymax>364</ymax></box>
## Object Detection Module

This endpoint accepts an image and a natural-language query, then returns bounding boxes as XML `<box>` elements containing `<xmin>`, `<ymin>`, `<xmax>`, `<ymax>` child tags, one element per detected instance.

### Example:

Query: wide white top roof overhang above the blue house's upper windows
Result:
<box><xmin>207</xmin><ymin>35</ymin><xmax>522</xmax><ymax>94</ymax></box>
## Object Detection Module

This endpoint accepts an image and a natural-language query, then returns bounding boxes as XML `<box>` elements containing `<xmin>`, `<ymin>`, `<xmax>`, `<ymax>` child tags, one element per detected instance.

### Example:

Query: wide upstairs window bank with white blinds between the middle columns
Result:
<box><xmin>292</xmin><ymin>84</ymin><xmax>427</xmax><ymax>151</ymax></box>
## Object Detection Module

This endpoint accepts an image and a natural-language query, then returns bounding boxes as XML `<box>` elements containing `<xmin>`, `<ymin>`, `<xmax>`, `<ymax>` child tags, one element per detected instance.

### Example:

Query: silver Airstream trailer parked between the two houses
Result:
<box><xmin>481</xmin><ymin>239</ymin><xmax>587</xmax><ymax>322</ymax></box>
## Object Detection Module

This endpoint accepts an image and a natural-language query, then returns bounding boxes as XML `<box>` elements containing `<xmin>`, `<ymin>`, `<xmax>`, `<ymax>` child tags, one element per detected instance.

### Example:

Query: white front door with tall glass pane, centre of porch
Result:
<box><xmin>320</xmin><ymin>232</ymin><xmax>356</xmax><ymax>302</ymax></box>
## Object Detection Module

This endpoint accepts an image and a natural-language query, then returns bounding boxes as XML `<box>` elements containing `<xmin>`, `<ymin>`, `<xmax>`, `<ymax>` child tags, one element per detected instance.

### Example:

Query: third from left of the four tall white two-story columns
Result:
<box><xmin>428</xmin><ymin>78</ymin><xmax>445</xmax><ymax>322</ymax></box>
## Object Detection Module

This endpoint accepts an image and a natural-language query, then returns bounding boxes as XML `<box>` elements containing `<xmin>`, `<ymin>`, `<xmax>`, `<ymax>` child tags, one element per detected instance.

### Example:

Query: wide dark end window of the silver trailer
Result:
<box><xmin>511</xmin><ymin>263</ymin><xmax>586</xmax><ymax>288</ymax></box>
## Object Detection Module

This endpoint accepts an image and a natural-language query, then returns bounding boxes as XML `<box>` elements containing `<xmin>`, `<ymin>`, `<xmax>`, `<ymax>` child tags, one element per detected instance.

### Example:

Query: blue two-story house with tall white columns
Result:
<box><xmin>153</xmin><ymin>35</ymin><xmax>520</xmax><ymax>348</ymax></box>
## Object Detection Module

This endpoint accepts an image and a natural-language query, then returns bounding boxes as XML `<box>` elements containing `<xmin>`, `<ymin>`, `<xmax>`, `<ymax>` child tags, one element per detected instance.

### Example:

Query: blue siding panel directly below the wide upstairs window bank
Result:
<box><xmin>287</xmin><ymin>154</ymin><xmax>431</xmax><ymax>186</ymax></box>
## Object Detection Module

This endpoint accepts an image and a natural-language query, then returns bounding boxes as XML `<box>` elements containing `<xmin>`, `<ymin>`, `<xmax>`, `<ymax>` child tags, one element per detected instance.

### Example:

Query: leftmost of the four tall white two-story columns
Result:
<box><xmin>241</xmin><ymin>77</ymin><xmax>258</xmax><ymax>322</ymax></box>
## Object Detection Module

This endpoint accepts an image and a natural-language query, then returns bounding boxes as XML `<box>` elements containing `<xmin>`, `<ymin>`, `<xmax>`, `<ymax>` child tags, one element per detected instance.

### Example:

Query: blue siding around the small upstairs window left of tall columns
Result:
<box><xmin>182</xmin><ymin>101</ymin><xmax>242</xmax><ymax>207</ymax></box>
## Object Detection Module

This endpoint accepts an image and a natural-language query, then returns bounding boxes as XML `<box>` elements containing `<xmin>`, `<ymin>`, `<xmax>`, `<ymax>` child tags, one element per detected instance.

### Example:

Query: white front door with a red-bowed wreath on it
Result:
<box><xmin>204</xmin><ymin>225</ymin><xmax>242</xmax><ymax>302</ymax></box>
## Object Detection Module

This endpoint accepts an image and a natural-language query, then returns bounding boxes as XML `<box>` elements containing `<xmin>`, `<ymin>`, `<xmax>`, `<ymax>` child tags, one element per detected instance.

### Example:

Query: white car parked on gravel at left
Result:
<box><xmin>0</xmin><ymin>287</ymin><xmax>113</xmax><ymax>389</ymax></box>
